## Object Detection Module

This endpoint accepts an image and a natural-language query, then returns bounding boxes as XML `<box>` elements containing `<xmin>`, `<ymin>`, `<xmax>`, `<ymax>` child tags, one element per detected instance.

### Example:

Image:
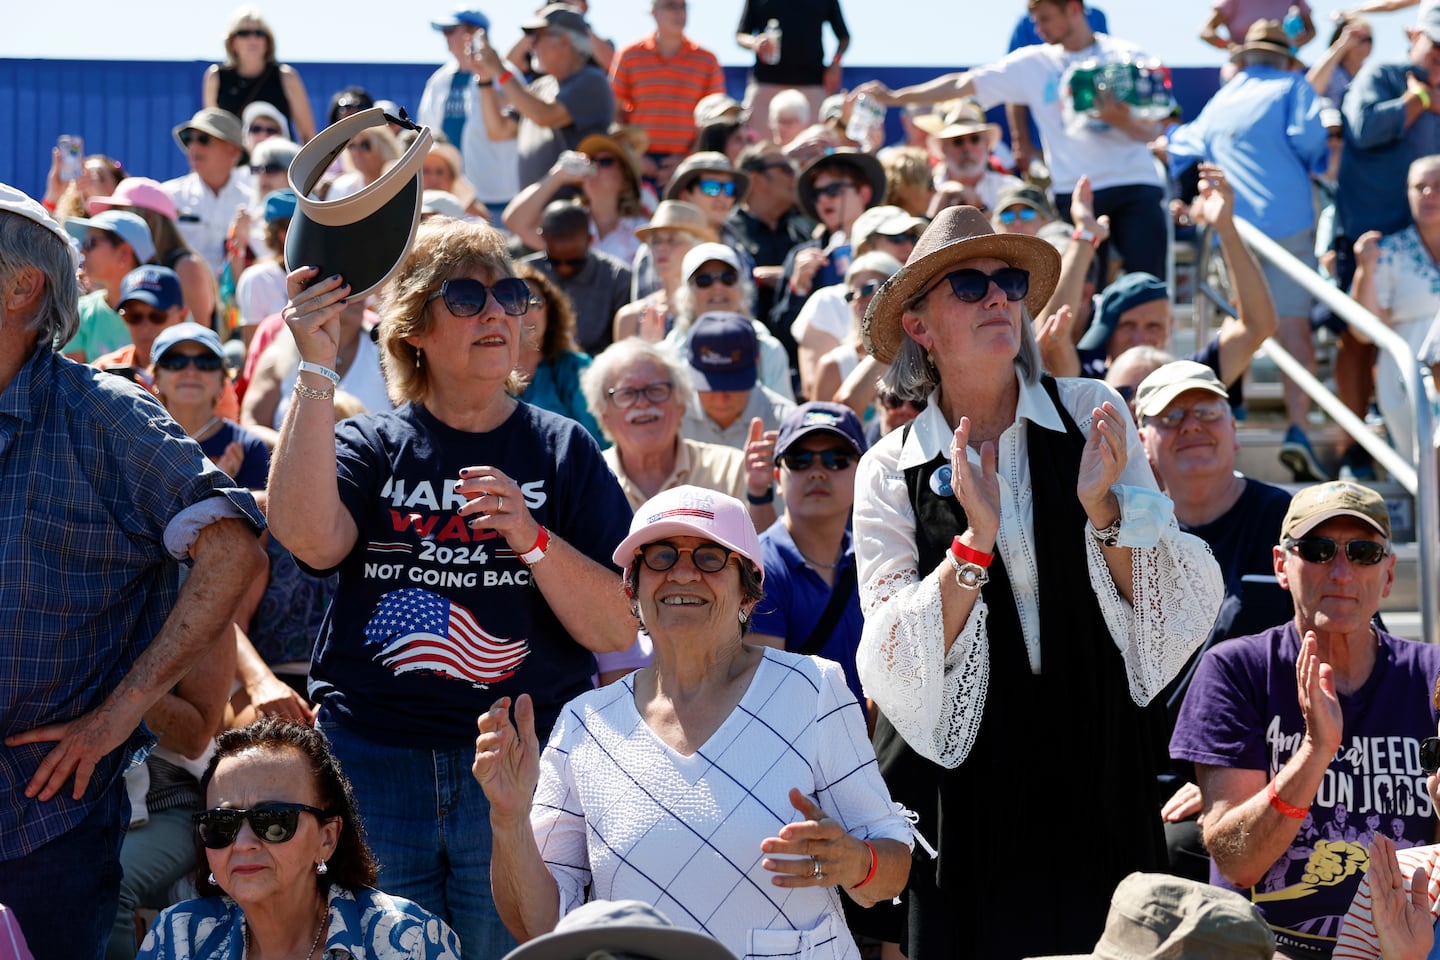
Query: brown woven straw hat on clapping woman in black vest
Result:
<box><xmin>863</xmin><ymin>207</ymin><xmax>1060</xmax><ymax>363</ymax></box>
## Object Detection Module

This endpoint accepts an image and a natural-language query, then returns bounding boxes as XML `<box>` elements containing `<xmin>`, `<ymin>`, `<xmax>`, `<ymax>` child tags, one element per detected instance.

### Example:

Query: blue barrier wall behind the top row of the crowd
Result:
<box><xmin>0</xmin><ymin>59</ymin><xmax>1218</xmax><ymax>197</ymax></box>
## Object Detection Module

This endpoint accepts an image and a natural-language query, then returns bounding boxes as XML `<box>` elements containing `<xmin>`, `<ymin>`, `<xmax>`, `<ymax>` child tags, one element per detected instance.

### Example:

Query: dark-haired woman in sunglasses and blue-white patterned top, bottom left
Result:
<box><xmin>140</xmin><ymin>718</ymin><xmax>459</xmax><ymax>960</ymax></box>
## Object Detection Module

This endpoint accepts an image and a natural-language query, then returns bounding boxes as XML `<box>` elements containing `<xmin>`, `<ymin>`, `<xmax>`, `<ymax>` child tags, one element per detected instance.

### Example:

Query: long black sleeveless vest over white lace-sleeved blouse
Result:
<box><xmin>861</xmin><ymin>376</ymin><xmax>1166</xmax><ymax>960</ymax></box>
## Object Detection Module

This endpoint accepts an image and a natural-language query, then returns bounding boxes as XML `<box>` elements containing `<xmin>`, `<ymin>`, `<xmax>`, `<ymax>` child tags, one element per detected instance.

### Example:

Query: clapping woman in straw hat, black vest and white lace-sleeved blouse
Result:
<box><xmin>855</xmin><ymin>206</ymin><xmax>1221</xmax><ymax>960</ymax></box>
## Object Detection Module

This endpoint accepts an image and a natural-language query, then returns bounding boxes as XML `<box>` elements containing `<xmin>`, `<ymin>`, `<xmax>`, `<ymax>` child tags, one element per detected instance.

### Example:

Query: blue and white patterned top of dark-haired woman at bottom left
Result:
<box><xmin>135</xmin><ymin>887</ymin><xmax>459</xmax><ymax>960</ymax></box>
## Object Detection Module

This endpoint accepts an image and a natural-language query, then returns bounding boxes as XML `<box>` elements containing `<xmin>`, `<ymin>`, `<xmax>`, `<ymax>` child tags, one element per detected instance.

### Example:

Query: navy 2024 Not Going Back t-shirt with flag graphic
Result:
<box><xmin>310</xmin><ymin>402</ymin><xmax>631</xmax><ymax>748</ymax></box>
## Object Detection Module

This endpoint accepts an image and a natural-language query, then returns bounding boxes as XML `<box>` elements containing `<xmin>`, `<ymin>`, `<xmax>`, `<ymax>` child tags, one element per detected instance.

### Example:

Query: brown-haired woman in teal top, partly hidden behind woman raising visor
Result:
<box><xmin>516</xmin><ymin>263</ymin><xmax>606</xmax><ymax>445</ymax></box>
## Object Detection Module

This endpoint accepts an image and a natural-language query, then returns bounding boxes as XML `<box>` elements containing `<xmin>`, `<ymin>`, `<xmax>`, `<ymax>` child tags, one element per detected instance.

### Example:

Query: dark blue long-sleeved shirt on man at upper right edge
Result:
<box><xmin>1335</xmin><ymin>63</ymin><xmax>1440</xmax><ymax>242</ymax></box>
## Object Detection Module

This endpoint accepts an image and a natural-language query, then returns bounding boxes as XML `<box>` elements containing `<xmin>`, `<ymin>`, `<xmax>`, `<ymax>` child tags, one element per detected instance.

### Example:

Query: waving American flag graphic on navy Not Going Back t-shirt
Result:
<box><xmin>364</xmin><ymin>587</ymin><xmax>530</xmax><ymax>688</ymax></box>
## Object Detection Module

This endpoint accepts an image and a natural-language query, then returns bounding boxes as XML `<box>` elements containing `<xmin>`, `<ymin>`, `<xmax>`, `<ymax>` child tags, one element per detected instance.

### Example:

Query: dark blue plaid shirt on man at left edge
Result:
<box><xmin>0</xmin><ymin>345</ymin><xmax>265</xmax><ymax>869</ymax></box>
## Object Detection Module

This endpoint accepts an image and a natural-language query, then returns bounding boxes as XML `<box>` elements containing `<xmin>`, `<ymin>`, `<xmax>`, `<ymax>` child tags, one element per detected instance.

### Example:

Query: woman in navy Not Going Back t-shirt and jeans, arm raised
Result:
<box><xmin>269</xmin><ymin>219</ymin><xmax>636</xmax><ymax>957</ymax></box>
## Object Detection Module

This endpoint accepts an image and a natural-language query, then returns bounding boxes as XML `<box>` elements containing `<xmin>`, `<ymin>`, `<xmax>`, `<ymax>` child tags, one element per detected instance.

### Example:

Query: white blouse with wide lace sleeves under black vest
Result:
<box><xmin>854</xmin><ymin>379</ymin><xmax>1224</xmax><ymax>767</ymax></box>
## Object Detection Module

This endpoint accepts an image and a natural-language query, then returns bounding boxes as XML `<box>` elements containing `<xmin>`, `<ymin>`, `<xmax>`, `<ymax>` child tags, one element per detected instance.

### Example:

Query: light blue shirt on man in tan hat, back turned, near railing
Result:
<box><xmin>1169</xmin><ymin>66</ymin><xmax>1329</xmax><ymax>237</ymax></box>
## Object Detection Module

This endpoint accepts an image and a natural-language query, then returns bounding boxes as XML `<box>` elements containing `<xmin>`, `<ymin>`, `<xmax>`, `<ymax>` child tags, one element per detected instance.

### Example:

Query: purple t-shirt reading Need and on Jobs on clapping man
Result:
<box><xmin>1171</xmin><ymin>622</ymin><xmax>1440</xmax><ymax>959</ymax></box>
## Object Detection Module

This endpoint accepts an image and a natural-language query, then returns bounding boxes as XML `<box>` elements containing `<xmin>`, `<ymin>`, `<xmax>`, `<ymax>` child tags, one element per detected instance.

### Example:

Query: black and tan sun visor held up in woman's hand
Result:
<box><xmin>285</xmin><ymin>107</ymin><xmax>432</xmax><ymax>298</ymax></box>
